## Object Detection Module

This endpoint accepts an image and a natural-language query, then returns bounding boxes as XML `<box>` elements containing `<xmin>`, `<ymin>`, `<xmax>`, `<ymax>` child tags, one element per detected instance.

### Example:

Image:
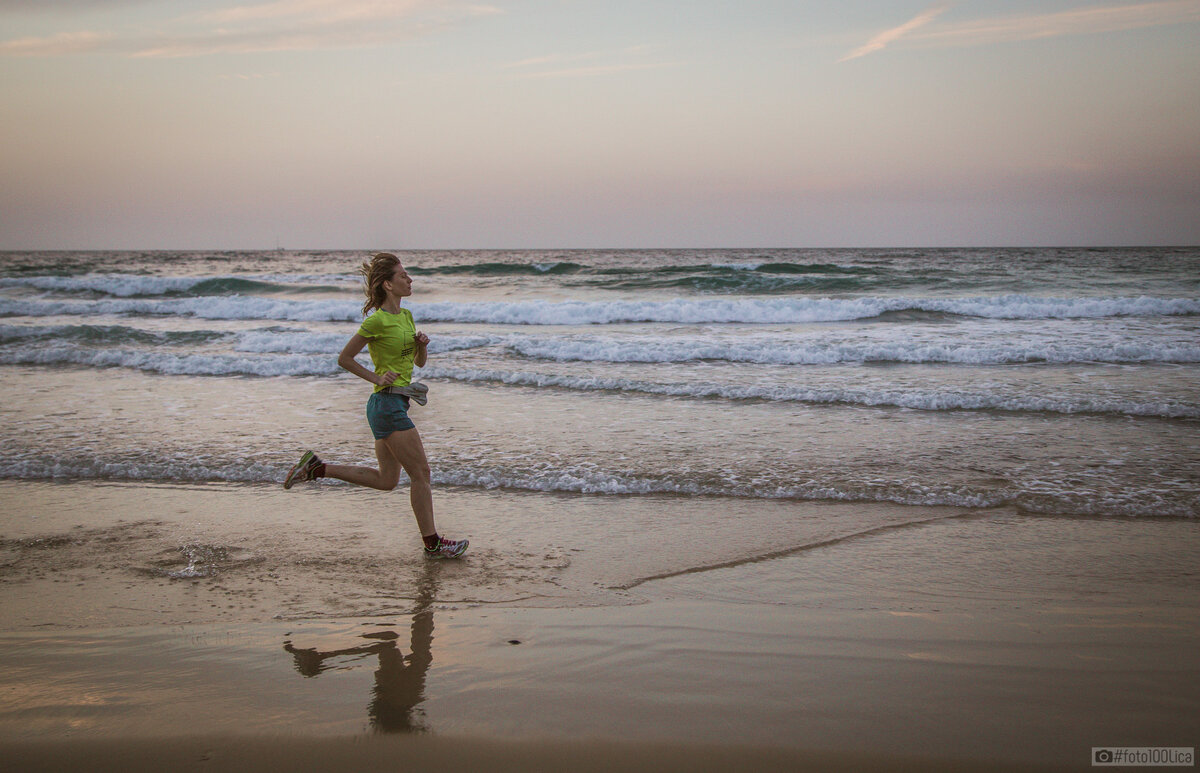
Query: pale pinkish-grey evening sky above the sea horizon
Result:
<box><xmin>0</xmin><ymin>0</ymin><xmax>1200</xmax><ymax>250</ymax></box>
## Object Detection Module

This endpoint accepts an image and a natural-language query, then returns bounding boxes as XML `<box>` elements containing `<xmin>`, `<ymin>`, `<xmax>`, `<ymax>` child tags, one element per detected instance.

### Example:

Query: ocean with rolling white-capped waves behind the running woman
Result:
<box><xmin>0</xmin><ymin>248</ymin><xmax>1200</xmax><ymax>519</ymax></box>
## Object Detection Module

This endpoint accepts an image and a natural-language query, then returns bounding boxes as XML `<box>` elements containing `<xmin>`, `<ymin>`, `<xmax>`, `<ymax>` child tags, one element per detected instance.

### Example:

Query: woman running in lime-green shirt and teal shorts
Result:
<box><xmin>283</xmin><ymin>252</ymin><xmax>467</xmax><ymax>558</ymax></box>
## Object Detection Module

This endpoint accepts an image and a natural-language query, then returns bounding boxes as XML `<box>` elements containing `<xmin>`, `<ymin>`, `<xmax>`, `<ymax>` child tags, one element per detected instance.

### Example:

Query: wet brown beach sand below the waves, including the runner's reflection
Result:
<box><xmin>0</xmin><ymin>481</ymin><xmax>1200</xmax><ymax>771</ymax></box>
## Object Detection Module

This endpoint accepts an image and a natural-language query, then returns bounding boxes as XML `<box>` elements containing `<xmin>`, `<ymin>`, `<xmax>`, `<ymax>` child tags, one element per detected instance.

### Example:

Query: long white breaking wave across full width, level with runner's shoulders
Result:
<box><xmin>0</xmin><ymin>294</ymin><xmax>1200</xmax><ymax>325</ymax></box>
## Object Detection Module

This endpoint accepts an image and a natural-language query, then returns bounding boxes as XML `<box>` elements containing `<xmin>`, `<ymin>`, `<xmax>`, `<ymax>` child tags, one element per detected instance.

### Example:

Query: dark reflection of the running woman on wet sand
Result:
<box><xmin>283</xmin><ymin>565</ymin><xmax>437</xmax><ymax>732</ymax></box>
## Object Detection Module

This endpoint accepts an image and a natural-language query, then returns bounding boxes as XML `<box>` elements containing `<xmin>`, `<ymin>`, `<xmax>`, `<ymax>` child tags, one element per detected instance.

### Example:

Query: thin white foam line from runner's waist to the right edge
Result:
<box><xmin>418</xmin><ymin>366</ymin><xmax>1200</xmax><ymax>419</ymax></box>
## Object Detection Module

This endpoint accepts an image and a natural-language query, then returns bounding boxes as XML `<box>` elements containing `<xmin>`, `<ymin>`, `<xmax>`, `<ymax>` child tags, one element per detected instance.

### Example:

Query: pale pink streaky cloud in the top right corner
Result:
<box><xmin>839</xmin><ymin>0</ymin><xmax>1200</xmax><ymax>61</ymax></box>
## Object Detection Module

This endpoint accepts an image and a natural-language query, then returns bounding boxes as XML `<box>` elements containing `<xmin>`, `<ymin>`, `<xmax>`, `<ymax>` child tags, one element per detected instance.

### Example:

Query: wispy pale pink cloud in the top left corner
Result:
<box><xmin>0</xmin><ymin>0</ymin><xmax>500</xmax><ymax>58</ymax></box>
